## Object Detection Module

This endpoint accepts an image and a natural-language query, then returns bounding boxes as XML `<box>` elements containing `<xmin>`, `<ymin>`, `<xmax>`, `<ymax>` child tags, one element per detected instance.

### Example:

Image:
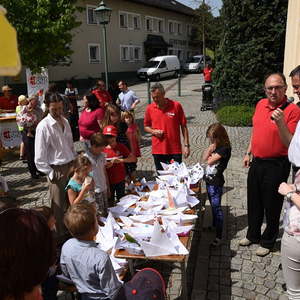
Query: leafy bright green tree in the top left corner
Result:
<box><xmin>1</xmin><ymin>0</ymin><xmax>80</xmax><ymax>71</ymax></box>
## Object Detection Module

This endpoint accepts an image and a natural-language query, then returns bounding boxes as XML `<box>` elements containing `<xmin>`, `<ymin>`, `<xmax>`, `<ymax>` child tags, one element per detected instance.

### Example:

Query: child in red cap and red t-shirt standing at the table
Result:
<box><xmin>103</xmin><ymin>125</ymin><xmax>136</xmax><ymax>206</ymax></box>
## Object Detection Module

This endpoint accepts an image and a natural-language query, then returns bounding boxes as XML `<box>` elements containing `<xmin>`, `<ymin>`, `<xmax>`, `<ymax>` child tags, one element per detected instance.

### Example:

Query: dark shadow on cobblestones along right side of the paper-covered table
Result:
<box><xmin>190</xmin><ymin>198</ymin><xmax>247</xmax><ymax>300</ymax></box>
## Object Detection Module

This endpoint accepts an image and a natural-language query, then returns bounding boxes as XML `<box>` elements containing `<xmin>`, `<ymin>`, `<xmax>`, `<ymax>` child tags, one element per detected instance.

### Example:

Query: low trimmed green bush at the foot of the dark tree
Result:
<box><xmin>216</xmin><ymin>105</ymin><xmax>255</xmax><ymax>126</ymax></box>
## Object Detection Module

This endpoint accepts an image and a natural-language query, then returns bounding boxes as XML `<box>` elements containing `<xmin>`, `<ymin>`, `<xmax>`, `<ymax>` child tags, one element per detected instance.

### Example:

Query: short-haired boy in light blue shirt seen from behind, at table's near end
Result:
<box><xmin>60</xmin><ymin>201</ymin><xmax>121</xmax><ymax>300</ymax></box>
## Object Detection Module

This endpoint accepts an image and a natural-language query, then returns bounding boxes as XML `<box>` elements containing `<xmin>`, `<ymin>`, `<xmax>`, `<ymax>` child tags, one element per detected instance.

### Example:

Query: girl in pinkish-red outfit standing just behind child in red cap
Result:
<box><xmin>122</xmin><ymin>111</ymin><xmax>141</xmax><ymax>181</ymax></box>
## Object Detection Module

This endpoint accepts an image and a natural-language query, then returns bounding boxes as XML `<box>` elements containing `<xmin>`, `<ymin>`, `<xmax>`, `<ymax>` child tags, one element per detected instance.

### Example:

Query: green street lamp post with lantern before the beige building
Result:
<box><xmin>94</xmin><ymin>0</ymin><xmax>112</xmax><ymax>89</ymax></box>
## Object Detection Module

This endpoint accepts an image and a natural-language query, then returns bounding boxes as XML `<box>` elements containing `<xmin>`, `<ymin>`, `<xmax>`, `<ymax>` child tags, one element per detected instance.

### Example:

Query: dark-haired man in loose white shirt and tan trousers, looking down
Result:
<box><xmin>34</xmin><ymin>93</ymin><xmax>75</xmax><ymax>239</ymax></box>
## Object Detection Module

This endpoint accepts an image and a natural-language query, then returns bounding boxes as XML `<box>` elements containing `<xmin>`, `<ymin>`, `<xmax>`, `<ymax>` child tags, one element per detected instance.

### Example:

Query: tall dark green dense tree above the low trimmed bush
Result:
<box><xmin>213</xmin><ymin>0</ymin><xmax>288</xmax><ymax>104</ymax></box>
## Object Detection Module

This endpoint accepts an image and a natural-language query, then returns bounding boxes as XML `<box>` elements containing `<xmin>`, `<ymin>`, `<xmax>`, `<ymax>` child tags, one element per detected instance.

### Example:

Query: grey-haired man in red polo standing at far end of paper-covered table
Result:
<box><xmin>144</xmin><ymin>83</ymin><xmax>190</xmax><ymax>170</ymax></box>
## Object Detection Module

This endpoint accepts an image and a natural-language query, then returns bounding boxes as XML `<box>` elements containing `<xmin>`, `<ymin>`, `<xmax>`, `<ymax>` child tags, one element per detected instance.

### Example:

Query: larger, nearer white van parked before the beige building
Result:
<box><xmin>137</xmin><ymin>55</ymin><xmax>180</xmax><ymax>80</ymax></box>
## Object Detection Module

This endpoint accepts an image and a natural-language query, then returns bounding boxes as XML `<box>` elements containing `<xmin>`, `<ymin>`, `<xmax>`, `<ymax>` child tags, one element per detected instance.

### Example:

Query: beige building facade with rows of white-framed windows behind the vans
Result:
<box><xmin>3</xmin><ymin>0</ymin><xmax>200</xmax><ymax>83</ymax></box>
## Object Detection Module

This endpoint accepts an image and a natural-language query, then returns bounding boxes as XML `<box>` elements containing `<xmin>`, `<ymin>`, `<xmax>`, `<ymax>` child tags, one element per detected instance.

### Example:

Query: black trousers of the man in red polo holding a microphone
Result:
<box><xmin>247</xmin><ymin>157</ymin><xmax>291</xmax><ymax>249</ymax></box>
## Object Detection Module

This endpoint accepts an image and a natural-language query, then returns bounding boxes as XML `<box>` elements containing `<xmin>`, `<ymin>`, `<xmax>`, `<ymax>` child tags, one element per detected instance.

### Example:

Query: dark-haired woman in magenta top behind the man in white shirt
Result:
<box><xmin>78</xmin><ymin>94</ymin><xmax>104</xmax><ymax>141</ymax></box>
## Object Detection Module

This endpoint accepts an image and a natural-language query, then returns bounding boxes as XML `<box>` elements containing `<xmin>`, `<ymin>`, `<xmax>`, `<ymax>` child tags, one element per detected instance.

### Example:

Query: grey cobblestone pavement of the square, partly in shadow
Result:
<box><xmin>1</xmin><ymin>74</ymin><xmax>285</xmax><ymax>300</ymax></box>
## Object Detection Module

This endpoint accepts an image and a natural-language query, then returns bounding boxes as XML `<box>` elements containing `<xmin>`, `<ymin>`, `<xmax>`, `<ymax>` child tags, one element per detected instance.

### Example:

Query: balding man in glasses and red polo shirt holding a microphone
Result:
<box><xmin>239</xmin><ymin>73</ymin><xmax>300</xmax><ymax>256</ymax></box>
